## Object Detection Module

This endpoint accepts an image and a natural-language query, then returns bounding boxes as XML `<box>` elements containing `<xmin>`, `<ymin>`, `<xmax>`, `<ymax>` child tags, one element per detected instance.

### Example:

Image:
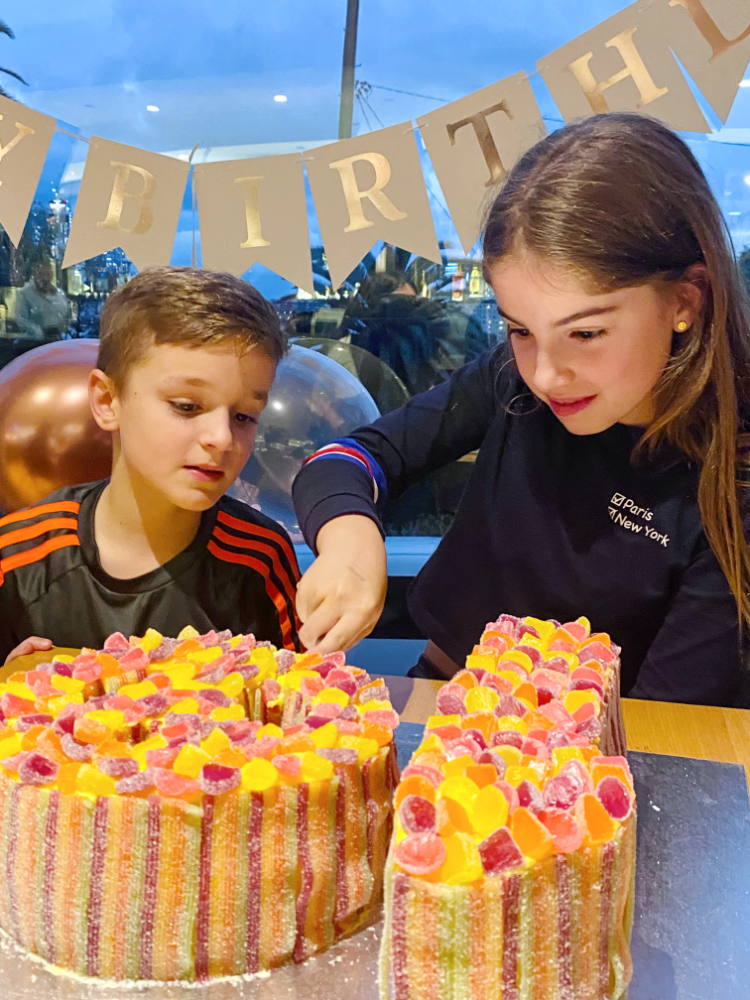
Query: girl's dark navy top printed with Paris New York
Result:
<box><xmin>294</xmin><ymin>351</ymin><xmax>741</xmax><ymax>704</ymax></box>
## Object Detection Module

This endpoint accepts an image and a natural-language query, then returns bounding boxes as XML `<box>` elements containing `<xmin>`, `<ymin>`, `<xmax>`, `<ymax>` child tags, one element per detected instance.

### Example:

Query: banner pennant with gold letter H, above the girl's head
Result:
<box><xmin>537</xmin><ymin>0</ymin><xmax>711</xmax><ymax>132</ymax></box>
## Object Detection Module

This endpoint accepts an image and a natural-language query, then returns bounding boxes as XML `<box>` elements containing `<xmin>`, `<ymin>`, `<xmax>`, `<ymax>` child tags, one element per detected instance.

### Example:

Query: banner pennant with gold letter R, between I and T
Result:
<box><xmin>305</xmin><ymin>122</ymin><xmax>440</xmax><ymax>288</ymax></box>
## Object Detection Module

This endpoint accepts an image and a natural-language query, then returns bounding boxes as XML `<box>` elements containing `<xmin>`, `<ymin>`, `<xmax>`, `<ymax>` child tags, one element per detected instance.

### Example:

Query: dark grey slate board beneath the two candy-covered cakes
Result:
<box><xmin>0</xmin><ymin>723</ymin><xmax>750</xmax><ymax>1000</ymax></box>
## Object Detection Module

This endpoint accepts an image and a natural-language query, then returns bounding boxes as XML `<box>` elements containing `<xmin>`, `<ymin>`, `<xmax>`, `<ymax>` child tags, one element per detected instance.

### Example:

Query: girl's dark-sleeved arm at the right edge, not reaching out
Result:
<box><xmin>627</xmin><ymin>544</ymin><xmax>743</xmax><ymax>706</ymax></box>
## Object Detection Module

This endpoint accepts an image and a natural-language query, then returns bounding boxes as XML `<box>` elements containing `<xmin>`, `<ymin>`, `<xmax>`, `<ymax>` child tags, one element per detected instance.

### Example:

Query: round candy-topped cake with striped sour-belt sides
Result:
<box><xmin>0</xmin><ymin>629</ymin><xmax>398</xmax><ymax>980</ymax></box>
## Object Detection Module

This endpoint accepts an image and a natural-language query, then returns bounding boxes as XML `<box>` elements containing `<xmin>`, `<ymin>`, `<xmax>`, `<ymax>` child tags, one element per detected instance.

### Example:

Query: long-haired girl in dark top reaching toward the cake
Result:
<box><xmin>294</xmin><ymin>113</ymin><xmax>750</xmax><ymax>705</ymax></box>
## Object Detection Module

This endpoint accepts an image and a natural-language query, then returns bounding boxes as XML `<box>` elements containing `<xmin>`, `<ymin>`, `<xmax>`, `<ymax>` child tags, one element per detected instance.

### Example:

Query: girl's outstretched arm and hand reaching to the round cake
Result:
<box><xmin>293</xmin><ymin>350</ymin><xmax>514</xmax><ymax>653</ymax></box>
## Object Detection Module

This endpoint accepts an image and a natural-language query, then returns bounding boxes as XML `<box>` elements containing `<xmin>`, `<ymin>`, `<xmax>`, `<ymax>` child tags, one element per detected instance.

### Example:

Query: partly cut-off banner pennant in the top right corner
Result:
<box><xmin>644</xmin><ymin>0</ymin><xmax>750</xmax><ymax>122</ymax></box>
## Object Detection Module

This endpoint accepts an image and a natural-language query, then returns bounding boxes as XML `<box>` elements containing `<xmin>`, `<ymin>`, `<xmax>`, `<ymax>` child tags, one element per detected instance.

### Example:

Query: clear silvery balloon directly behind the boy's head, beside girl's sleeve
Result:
<box><xmin>229</xmin><ymin>345</ymin><xmax>380</xmax><ymax>541</ymax></box>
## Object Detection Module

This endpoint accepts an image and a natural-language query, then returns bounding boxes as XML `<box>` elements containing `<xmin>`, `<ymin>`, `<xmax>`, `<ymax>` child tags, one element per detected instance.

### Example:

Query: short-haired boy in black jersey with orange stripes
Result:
<box><xmin>0</xmin><ymin>267</ymin><xmax>299</xmax><ymax>662</ymax></box>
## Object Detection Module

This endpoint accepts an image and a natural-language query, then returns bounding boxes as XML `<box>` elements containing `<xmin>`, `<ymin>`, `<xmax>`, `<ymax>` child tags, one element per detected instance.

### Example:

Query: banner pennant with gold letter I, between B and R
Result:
<box><xmin>193</xmin><ymin>153</ymin><xmax>314</xmax><ymax>293</ymax></box>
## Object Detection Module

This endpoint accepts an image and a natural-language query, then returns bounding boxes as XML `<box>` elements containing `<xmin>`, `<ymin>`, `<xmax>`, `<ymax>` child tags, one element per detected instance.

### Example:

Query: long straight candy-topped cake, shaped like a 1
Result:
<box><xmin>380</xmin><ymin>615</ymin><xmax>636</xmax><ymax>1000</ymax></box>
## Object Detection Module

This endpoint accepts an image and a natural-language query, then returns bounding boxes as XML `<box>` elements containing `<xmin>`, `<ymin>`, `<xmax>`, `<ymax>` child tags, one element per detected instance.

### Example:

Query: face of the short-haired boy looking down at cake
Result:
<box><xmin>100</xmin><ymin>342</ymin><xmax>276</xmax><ymax>511</ymax></box>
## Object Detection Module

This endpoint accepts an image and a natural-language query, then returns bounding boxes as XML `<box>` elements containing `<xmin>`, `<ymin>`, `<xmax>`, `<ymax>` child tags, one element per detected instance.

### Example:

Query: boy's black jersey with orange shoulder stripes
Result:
<box><xmin>0</xmin><ymin>480</ymin><xmax>299</xmax><ymax>663</ymax></box>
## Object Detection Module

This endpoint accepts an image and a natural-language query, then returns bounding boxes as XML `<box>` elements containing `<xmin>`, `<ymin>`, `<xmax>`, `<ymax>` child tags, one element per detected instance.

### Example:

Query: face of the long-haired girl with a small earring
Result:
<box><xmin>491</xmin><ymin>253</ymin><xmax>700</xmax><ymax>434</ymax></box>
